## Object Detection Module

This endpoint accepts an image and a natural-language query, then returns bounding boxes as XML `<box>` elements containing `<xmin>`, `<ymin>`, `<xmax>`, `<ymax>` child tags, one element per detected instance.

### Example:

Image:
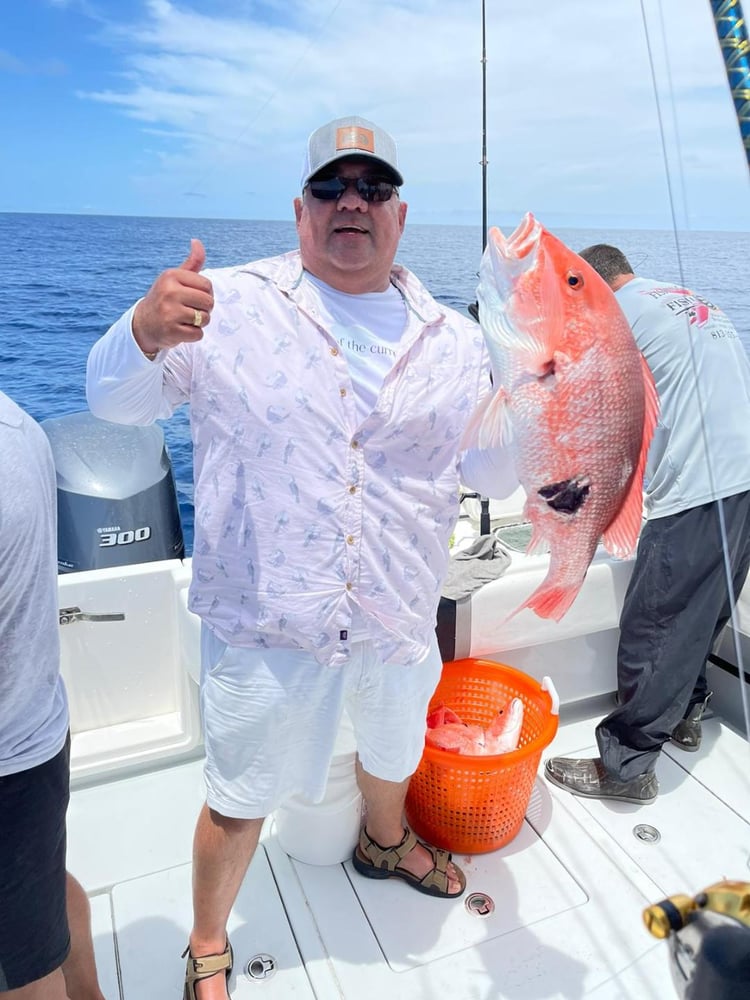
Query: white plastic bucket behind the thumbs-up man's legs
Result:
<box><xmin>274</xmin><ymin>714</ymin><xmax>362</xmax><ymax>865</ymax></box>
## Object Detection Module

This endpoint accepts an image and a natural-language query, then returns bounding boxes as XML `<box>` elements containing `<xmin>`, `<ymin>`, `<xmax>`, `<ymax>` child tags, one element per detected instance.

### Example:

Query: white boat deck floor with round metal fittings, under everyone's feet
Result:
<box><xmin>69</xmin><ymin>697</ymin><xmax>750</xmax><ymax>1000</ymax></box>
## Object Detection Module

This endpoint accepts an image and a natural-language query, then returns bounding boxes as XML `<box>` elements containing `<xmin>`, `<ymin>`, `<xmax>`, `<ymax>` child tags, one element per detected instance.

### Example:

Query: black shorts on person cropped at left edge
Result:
<box><xmin>0</xmin><ymin>737</ymin><xmax>70</xmax><ymax>993</ymax></box>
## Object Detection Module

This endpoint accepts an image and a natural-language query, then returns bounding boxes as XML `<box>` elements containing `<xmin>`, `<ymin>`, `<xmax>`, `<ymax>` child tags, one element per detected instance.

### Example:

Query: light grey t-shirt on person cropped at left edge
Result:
<box><xmin>0</xmin><ymin>392</ymin><xmax>69</xmax><ymax>776</ymax></box>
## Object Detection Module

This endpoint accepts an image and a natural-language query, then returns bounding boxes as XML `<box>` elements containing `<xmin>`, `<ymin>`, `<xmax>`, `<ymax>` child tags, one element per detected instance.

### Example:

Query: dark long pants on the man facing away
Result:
<box><xmin>596</xmin><ymin>491</ymin><xmax>750</xmax><ymax>781</ymax></box>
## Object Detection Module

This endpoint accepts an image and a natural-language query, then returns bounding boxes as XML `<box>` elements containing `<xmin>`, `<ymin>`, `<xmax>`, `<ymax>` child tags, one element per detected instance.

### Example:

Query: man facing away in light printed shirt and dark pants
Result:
<box><xmin>545</xmin><ymin>244</ymin><xmax>750</xmax><ymax>803</ymax></box>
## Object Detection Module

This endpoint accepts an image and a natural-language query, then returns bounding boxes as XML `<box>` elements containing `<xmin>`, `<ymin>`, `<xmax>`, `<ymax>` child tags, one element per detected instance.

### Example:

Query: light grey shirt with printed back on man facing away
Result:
<box><xmin>615</xmin><ymin>278</ymin><xmax>750</xmax><ymax>517</ymax></box>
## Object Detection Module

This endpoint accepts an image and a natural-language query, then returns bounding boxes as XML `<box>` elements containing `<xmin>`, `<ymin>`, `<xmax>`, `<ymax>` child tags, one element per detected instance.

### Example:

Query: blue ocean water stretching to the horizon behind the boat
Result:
<box><xmin>0</xmin><ymin>213</ymin><xmax>750</xmax><ymax>552</ymax></box>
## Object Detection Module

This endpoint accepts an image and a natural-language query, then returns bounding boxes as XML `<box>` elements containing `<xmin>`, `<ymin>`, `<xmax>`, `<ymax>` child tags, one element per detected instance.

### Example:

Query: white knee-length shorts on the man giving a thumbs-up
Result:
<box><xmin>201</xmin><ymin>625</ymin><xmax>442</xmax><ymax>819</ymax></box>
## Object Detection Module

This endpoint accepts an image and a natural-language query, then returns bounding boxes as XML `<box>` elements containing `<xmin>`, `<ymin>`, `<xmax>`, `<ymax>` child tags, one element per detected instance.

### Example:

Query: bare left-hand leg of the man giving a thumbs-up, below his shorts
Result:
<box><xmin>190</xmin><ymin>805</ymin><xmax>263</xmax><ymax>1000</ymax></box>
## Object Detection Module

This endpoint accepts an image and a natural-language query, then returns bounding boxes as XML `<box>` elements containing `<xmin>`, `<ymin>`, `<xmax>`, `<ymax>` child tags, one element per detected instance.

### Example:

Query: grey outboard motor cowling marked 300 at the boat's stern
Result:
<box><xmin>42</xmin><ymin>412</ymin><xmax>185</xmax><ymax>573</ymax></box>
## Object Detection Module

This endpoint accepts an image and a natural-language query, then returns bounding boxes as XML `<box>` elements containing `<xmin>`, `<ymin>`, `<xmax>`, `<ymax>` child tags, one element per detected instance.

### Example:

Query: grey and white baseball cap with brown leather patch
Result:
<box><xmin>302</xmin><ymin>115</ymin><xmax>404</xmax><ymax>188</ymax></box>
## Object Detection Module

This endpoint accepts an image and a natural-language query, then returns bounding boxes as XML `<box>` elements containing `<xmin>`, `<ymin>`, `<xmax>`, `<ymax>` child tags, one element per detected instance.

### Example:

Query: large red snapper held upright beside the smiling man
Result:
<box><xmin>465</xmin><ymin>213</ymin><xmax>659</xmax><ymax>621</ymax></box>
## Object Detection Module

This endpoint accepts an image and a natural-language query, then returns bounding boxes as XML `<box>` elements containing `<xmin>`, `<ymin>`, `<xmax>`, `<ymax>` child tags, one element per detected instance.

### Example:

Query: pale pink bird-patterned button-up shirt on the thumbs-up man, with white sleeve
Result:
<box><xmin>88</xmin><ymin>251</ymin><xmax>490</xmax><ymax>664</ymax></box>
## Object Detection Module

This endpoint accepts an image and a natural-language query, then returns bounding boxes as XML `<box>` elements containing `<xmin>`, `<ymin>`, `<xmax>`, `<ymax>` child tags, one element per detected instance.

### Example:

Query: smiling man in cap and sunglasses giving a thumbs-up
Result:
<box><xmin>88</xmin><ymin>117</ymin><xmax>516</xmax><ymax>1000</ymax></box>
